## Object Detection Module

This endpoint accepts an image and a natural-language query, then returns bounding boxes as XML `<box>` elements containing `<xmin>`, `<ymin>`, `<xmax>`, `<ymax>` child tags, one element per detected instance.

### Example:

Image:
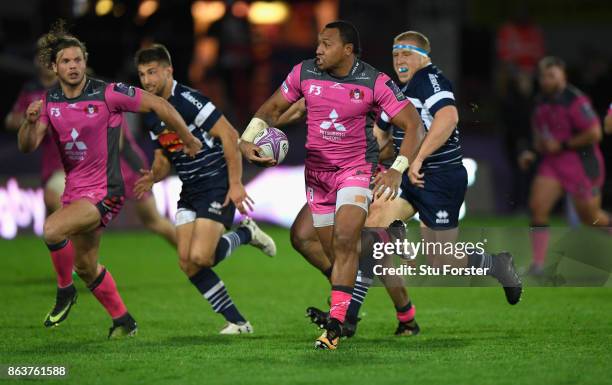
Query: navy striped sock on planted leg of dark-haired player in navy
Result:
<box><xmin>189</xmin><ymin>267</ymin><xmax>246</xmax><ymax>324</ymax></box>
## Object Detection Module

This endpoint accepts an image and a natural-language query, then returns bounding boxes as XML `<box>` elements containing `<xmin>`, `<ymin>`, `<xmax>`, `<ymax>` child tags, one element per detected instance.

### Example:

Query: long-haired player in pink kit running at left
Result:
<box><xmin>18</xmin><ymin>23</ymin><xmax>202</xmax><ymax>338</ymax></box>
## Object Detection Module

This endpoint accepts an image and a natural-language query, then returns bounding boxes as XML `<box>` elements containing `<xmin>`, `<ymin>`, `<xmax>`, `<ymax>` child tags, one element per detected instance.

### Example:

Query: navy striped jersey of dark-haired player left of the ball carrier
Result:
<box><xmin>144</xmin><ymin>81</ymin><xmax>227</xmax><ymax>193</ymax></box>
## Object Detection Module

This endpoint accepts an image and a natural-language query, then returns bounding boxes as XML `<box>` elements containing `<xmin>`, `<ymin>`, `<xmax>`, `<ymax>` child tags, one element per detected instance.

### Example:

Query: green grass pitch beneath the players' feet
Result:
<box><xmin>0</xmin><ymin>225</ymin><xmax>612</xmax><ymax>385</ymax></box>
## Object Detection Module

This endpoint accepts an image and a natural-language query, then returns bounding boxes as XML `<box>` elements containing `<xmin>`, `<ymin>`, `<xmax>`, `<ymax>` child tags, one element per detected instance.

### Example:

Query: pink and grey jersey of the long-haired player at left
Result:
<box><xmin>41</xmin><ymin>78</ymin><xmax>142</xmax><ymax>200</ymax></box>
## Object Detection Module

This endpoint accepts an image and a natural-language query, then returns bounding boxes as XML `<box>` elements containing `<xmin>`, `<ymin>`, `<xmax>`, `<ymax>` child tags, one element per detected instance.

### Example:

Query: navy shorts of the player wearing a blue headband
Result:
<box><xmin>400</xmin><ymin>165</ymin><xmax>467</xmax><ymax>230</ymax></box>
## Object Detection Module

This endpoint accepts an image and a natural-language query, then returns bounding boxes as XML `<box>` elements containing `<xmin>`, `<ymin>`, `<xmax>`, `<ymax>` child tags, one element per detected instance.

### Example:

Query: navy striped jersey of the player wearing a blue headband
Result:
<box><xmin>377</xmin><ymin>64</ymin><xmax>463</xmax><ymax>171</ymax></box>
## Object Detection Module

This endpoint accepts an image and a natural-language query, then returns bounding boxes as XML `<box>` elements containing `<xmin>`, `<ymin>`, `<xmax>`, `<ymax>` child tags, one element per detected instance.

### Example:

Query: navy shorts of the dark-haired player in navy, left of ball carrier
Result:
<box><xmin>176</xmin><ymin>187</ymin><xmax>236</xmax><ymax>229</ymax></box>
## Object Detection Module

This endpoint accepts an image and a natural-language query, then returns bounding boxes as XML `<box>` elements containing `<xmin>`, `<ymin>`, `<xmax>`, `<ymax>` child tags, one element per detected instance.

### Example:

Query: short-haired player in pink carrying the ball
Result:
<box><xmin>240</xmin><ymin>21</ymin><xmax>422</xmax><ymax>349</ymax></box>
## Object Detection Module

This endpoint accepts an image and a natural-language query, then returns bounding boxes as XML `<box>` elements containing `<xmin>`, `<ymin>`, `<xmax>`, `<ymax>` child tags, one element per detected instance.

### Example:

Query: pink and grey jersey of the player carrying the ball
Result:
<box><xmin>281</xmin><ymin>59</ymin><xmax>410</xmax><ymax>170</ymax></box>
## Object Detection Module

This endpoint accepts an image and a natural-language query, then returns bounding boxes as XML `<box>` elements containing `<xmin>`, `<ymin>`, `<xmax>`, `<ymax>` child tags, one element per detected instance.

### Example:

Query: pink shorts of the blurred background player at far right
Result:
<box><xmin>538</xmin><ymin>148</ymin><xmax>605</xmax><ymax>200</ymax></box>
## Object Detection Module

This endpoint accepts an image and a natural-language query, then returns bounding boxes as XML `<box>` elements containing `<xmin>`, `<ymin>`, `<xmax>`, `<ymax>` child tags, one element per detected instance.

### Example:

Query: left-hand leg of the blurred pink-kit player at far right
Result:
<box><xmin>529</xmin><ymin>175</ymin><xmax>564</xmax><ymax>275</ymax></box>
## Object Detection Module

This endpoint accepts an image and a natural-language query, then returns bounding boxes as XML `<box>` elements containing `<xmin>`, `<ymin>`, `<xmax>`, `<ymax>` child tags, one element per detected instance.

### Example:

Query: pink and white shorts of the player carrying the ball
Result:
<box><xmin>304</xmin><ymin>163</ymin><xmax>376</xmax><ymax>227</ymax></box>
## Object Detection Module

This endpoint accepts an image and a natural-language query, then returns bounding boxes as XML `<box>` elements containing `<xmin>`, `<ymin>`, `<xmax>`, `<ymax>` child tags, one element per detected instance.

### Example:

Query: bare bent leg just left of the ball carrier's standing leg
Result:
<box><xmin>290</xmin><ymin>204</ymin><xmax>332</xmax><ymax>280</ymax></box>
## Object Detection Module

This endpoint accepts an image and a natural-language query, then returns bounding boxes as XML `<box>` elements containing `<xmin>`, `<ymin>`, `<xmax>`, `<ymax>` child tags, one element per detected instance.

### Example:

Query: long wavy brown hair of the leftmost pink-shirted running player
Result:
<box><xmin>36</xmin><ymin>19</ymin><xmax>87</xmax><ymax>68</ymax></box>
